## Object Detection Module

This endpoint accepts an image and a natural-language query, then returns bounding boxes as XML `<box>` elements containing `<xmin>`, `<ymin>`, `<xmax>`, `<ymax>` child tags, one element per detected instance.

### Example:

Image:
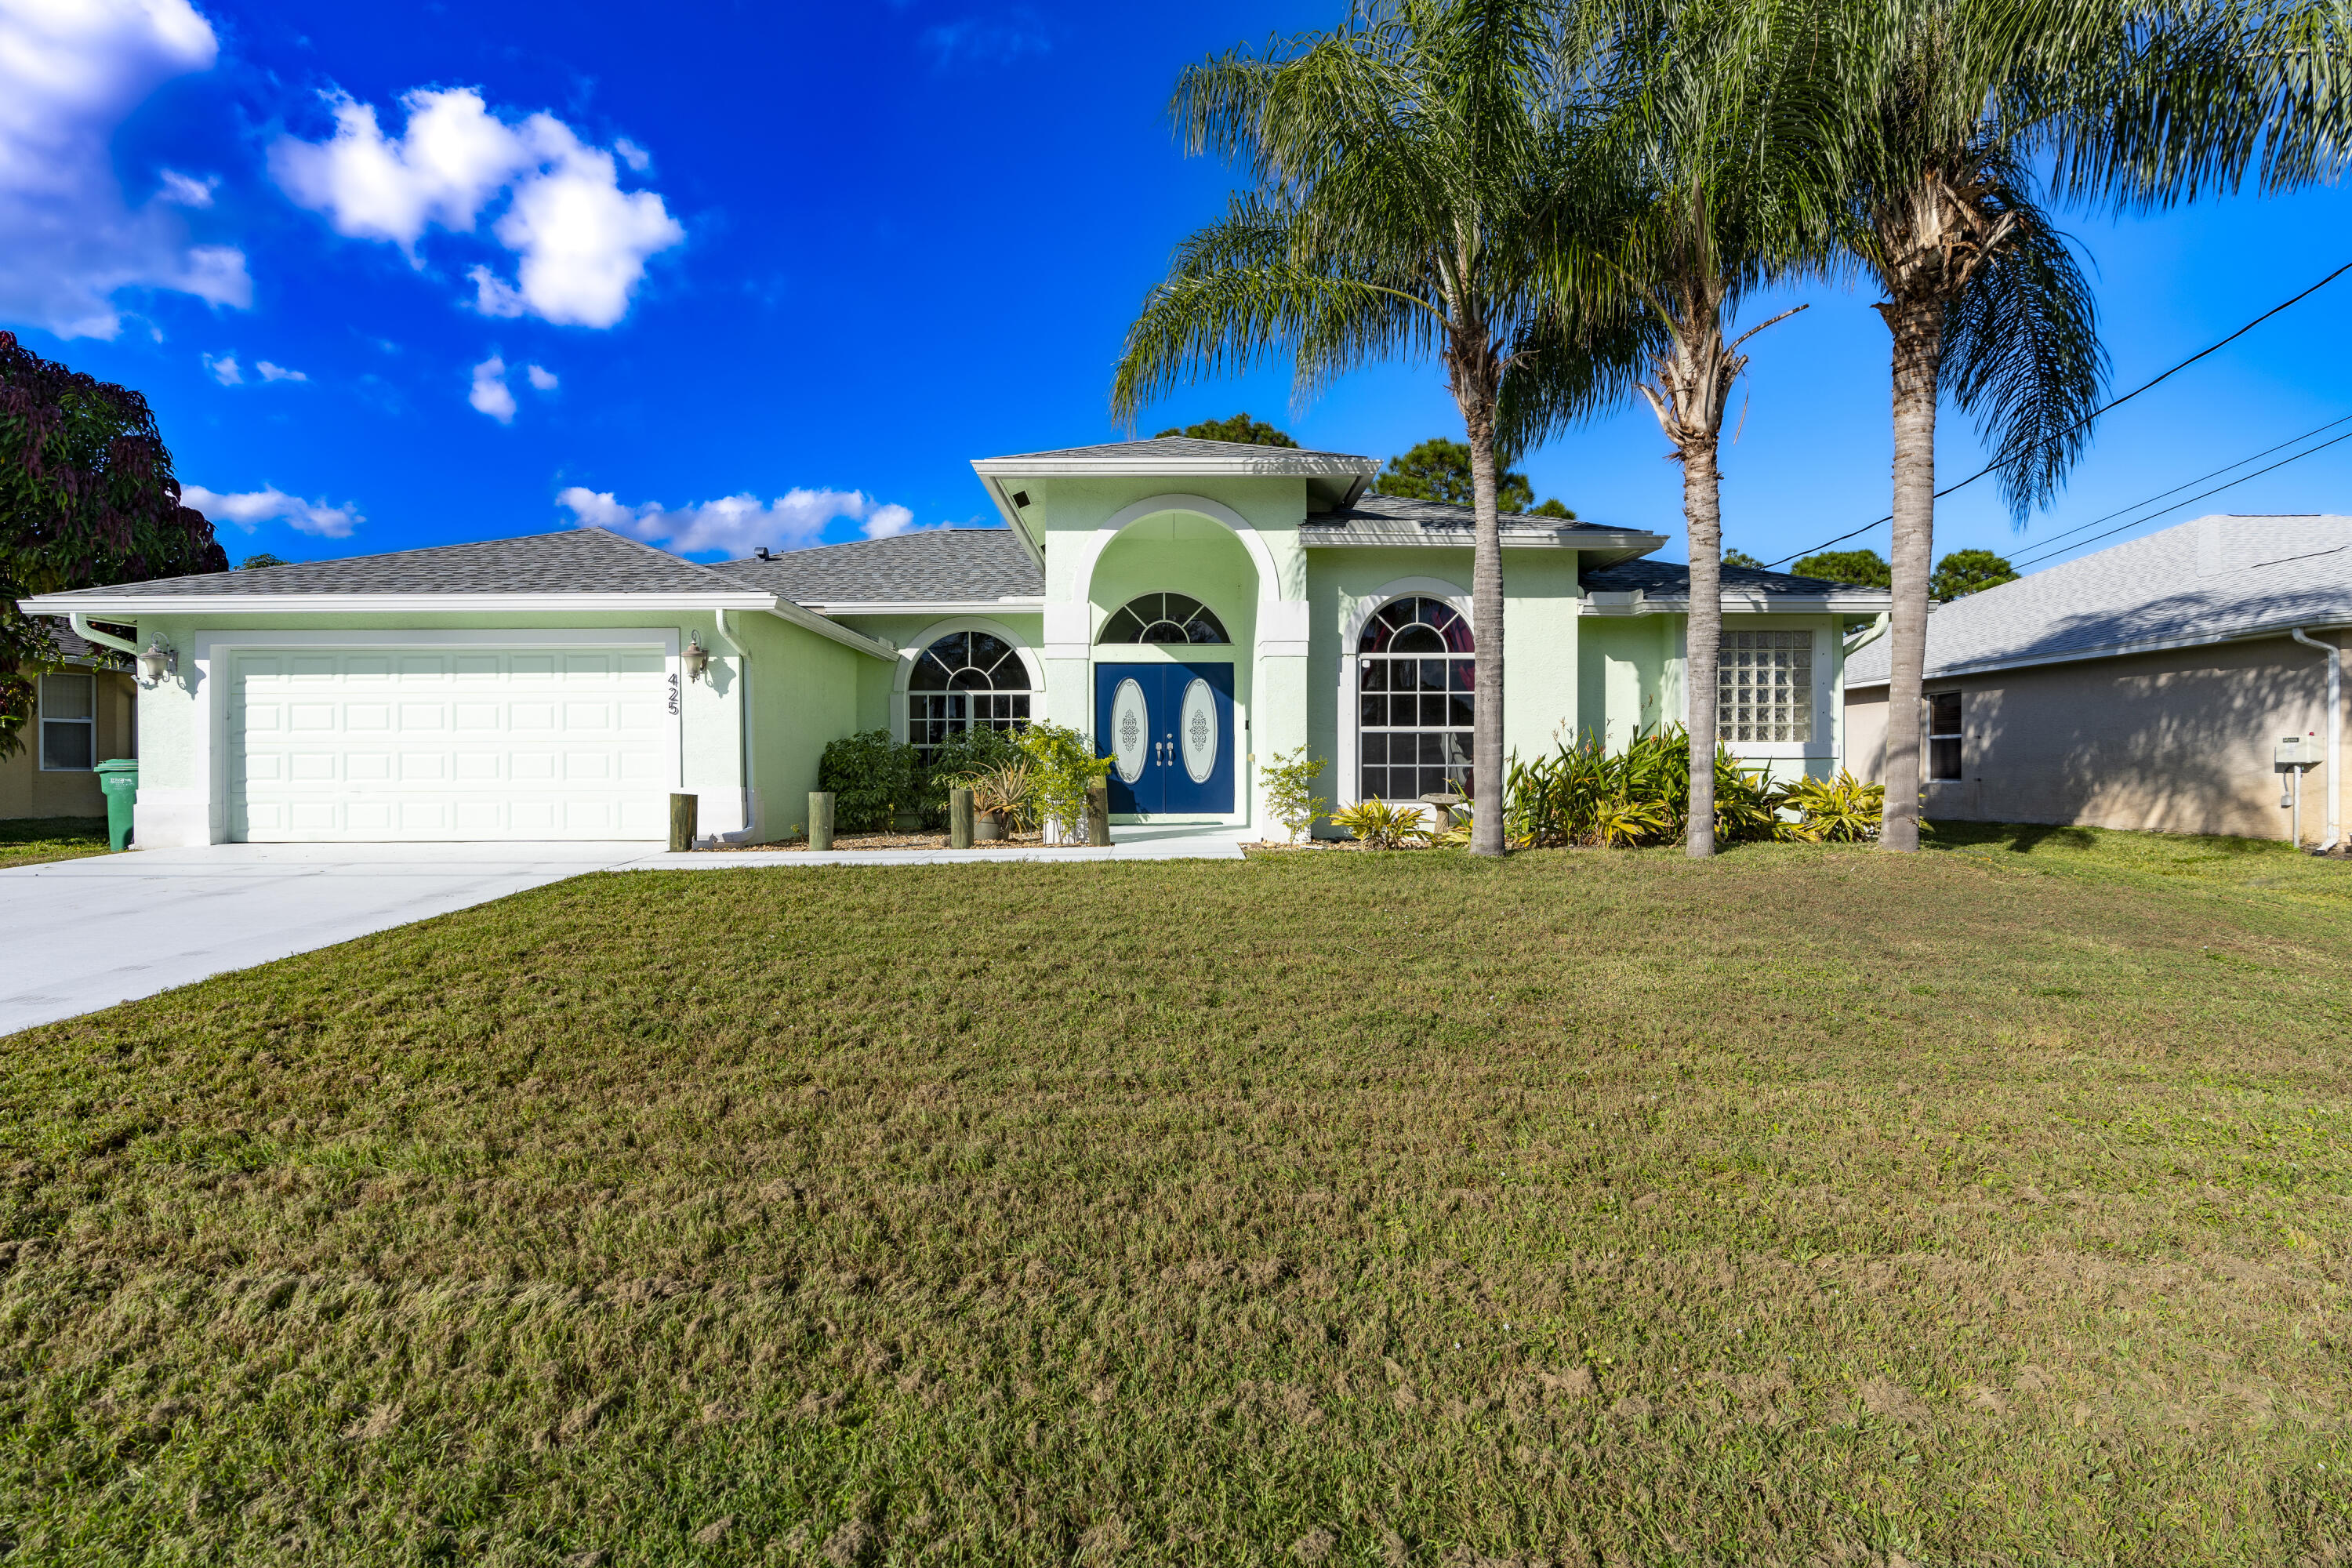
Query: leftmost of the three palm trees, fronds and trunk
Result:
<box><xmin>1110</xmin><ymin>0</ymin><xmax>1637</xmax><ymax>855</ymax></box>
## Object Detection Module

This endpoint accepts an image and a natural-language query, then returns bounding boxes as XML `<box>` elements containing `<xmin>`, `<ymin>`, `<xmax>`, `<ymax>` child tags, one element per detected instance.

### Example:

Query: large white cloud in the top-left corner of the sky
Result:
<box><xmin>0</xmin><ymin>0</ymin><xmax>252</xmax><ymax>339</ymax></box>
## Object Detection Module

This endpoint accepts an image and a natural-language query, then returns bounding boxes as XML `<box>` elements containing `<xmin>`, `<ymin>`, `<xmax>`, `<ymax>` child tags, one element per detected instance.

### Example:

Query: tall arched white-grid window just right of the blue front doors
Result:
<box><xmin>1355</xmin><ymin>597</ymin><xmax>1477</xmax><ymax>799</ymax></box>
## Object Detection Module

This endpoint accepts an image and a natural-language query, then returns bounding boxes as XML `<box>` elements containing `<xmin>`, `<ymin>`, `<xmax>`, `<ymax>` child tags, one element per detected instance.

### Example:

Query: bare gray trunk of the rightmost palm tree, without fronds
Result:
<box><xmin>1879</xmin><ymin>292</ymin><xmax>1943</xmax><ymax>853</ymax></box>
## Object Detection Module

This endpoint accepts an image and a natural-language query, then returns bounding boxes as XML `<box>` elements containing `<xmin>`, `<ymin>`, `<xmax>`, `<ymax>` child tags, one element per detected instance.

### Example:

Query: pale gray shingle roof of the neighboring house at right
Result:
<box><xmin>1846</xmin><ymin>517</ymin><xmax>2352</xmax><ymax>687</ymax></box>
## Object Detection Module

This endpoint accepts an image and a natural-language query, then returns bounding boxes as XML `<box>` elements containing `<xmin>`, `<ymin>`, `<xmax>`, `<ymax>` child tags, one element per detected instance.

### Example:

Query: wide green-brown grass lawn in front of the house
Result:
<box><xmin>0</xmin><ymin>827</ymin><xmax>2352</xmax><ymax>1568</ymax></box>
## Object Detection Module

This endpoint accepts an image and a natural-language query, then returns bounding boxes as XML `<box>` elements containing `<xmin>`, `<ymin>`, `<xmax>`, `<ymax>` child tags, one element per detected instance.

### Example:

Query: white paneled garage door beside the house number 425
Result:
<box><xmin>228</xmin><ymin>647</ymin><xmax>677</xmax><ymax>844</ymax></box>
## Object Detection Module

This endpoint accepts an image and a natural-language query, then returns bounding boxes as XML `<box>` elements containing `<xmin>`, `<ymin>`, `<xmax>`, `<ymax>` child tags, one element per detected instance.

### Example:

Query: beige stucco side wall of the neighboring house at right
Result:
<box><xmin>1846</xmin><ymin>635</ymin><xmax>2352</xmax><ymax>844</ymax></box>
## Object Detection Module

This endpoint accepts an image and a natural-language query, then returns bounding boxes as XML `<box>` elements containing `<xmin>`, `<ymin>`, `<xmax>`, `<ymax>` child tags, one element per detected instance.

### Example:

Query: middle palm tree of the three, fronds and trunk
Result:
<box><xmin>1562</xmin><ymin>0</ymin><xmax>1839</xmax><ymax>858</ymax></box>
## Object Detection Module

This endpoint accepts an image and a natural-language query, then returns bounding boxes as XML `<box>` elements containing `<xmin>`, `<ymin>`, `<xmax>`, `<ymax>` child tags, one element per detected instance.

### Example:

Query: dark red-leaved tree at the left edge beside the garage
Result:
<box><xmin>0</xmin><ymin>332</ymin><xmax>228</xmax><ymax>757</ymax></box>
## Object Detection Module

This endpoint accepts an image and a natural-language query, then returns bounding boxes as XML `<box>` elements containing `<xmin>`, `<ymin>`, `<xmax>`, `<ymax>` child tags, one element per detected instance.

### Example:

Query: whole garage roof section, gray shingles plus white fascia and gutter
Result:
<box><xmin>24</xmin><ymin>529</ymin><xmax>894</xmax><ymax>656</ymax></box>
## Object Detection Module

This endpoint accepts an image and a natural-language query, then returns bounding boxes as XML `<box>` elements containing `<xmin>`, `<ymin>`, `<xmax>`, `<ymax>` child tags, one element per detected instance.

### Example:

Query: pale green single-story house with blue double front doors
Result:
<box><xmin>13</xmin><ymin>437</ymin><xmax>1886</xmax><ymax>846</ymax></box>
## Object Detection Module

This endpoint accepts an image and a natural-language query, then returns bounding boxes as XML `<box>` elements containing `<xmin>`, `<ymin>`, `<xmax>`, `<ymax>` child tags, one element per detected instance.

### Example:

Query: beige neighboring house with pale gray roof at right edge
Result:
<box><xmin>1846</xmin><ymin>517</ymin><xmax>2352</xmax><ymax>844</ymax></box>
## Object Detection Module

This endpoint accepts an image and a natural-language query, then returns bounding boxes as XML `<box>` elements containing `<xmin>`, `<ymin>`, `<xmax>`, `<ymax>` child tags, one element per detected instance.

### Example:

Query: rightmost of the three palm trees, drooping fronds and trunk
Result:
<box><xmin>1842</xmin><ymin>0</ymin><xmax>2345</xmax><ymax>851</ymax></box>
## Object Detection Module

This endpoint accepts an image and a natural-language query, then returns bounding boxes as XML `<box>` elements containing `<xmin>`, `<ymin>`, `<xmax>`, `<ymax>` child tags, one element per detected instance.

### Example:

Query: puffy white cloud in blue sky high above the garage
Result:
<box><xmin>270</xmin><ymin>87</ymin><xmax>687</xmax><ymax>327</ymax></box>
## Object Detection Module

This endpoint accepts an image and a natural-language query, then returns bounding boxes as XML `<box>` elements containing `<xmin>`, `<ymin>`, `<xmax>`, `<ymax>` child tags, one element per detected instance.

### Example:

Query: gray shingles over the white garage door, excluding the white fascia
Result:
<box><xmin>25</xmin><ymin>529</ymin><xmax>736</xmax><ymax>600</ymax></box>
